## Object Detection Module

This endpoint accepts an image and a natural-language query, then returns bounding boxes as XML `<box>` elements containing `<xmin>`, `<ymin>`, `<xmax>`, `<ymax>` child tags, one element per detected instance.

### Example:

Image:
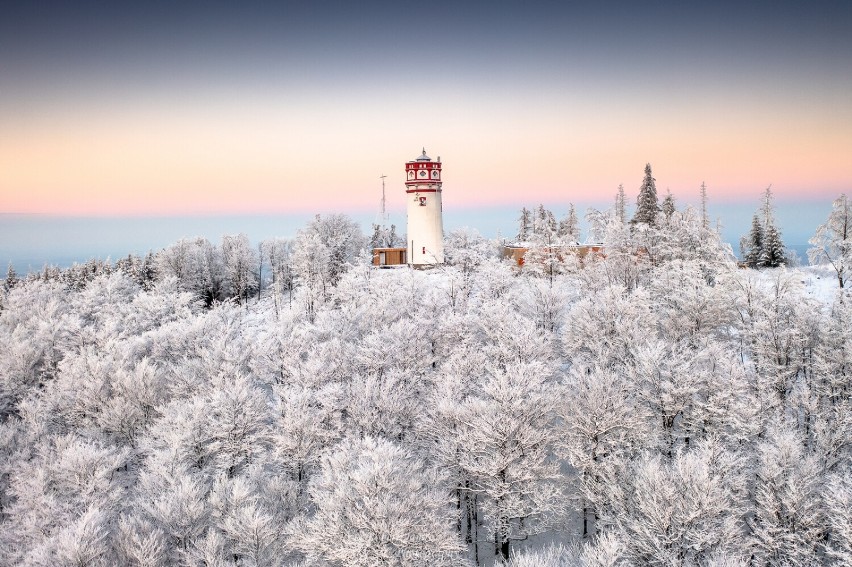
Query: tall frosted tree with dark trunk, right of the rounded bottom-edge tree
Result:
<box><xmin>456</xmin><ymin>362</ymin><xmax>562</xmax><ymax>559</ymax></box>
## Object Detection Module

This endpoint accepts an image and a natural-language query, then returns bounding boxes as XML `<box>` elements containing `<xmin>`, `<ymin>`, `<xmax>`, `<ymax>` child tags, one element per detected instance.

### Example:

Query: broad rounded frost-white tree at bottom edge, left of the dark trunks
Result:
<box><xmin>293</xmin><ymin>437</ymin><xmax>465</xmax><ymax>567</ymax></box>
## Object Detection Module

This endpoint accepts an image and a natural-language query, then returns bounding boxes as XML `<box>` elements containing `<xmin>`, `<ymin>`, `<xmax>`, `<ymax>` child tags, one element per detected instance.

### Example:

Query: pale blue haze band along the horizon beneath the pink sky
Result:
<box><xmin>0</xmin><ymin>198</ymin><xmax>831</xmax><ymax>275</ymax></box>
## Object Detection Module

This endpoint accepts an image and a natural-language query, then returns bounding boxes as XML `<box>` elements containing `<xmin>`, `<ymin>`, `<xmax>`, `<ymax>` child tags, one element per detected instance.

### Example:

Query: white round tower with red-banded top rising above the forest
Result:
<box><xmin>405</xmin><ymin>148</ymin><xmax>444</xmax><ymax>266</ymax></box>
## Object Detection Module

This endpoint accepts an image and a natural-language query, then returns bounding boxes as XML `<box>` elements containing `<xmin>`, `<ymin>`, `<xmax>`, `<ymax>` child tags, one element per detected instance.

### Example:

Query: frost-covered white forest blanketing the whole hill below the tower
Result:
<box><xmin>0</xmin><ymin>192</ymin><xmax>852</xmax><ymax>567</ymax></box>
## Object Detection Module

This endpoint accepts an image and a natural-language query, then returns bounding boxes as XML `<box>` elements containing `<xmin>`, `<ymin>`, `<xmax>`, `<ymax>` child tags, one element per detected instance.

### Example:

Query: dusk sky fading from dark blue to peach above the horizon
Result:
<box><xmin>0</xmin><ymin>0</ymin><xmax>852</xmax><ymax>266</ymax></box>
